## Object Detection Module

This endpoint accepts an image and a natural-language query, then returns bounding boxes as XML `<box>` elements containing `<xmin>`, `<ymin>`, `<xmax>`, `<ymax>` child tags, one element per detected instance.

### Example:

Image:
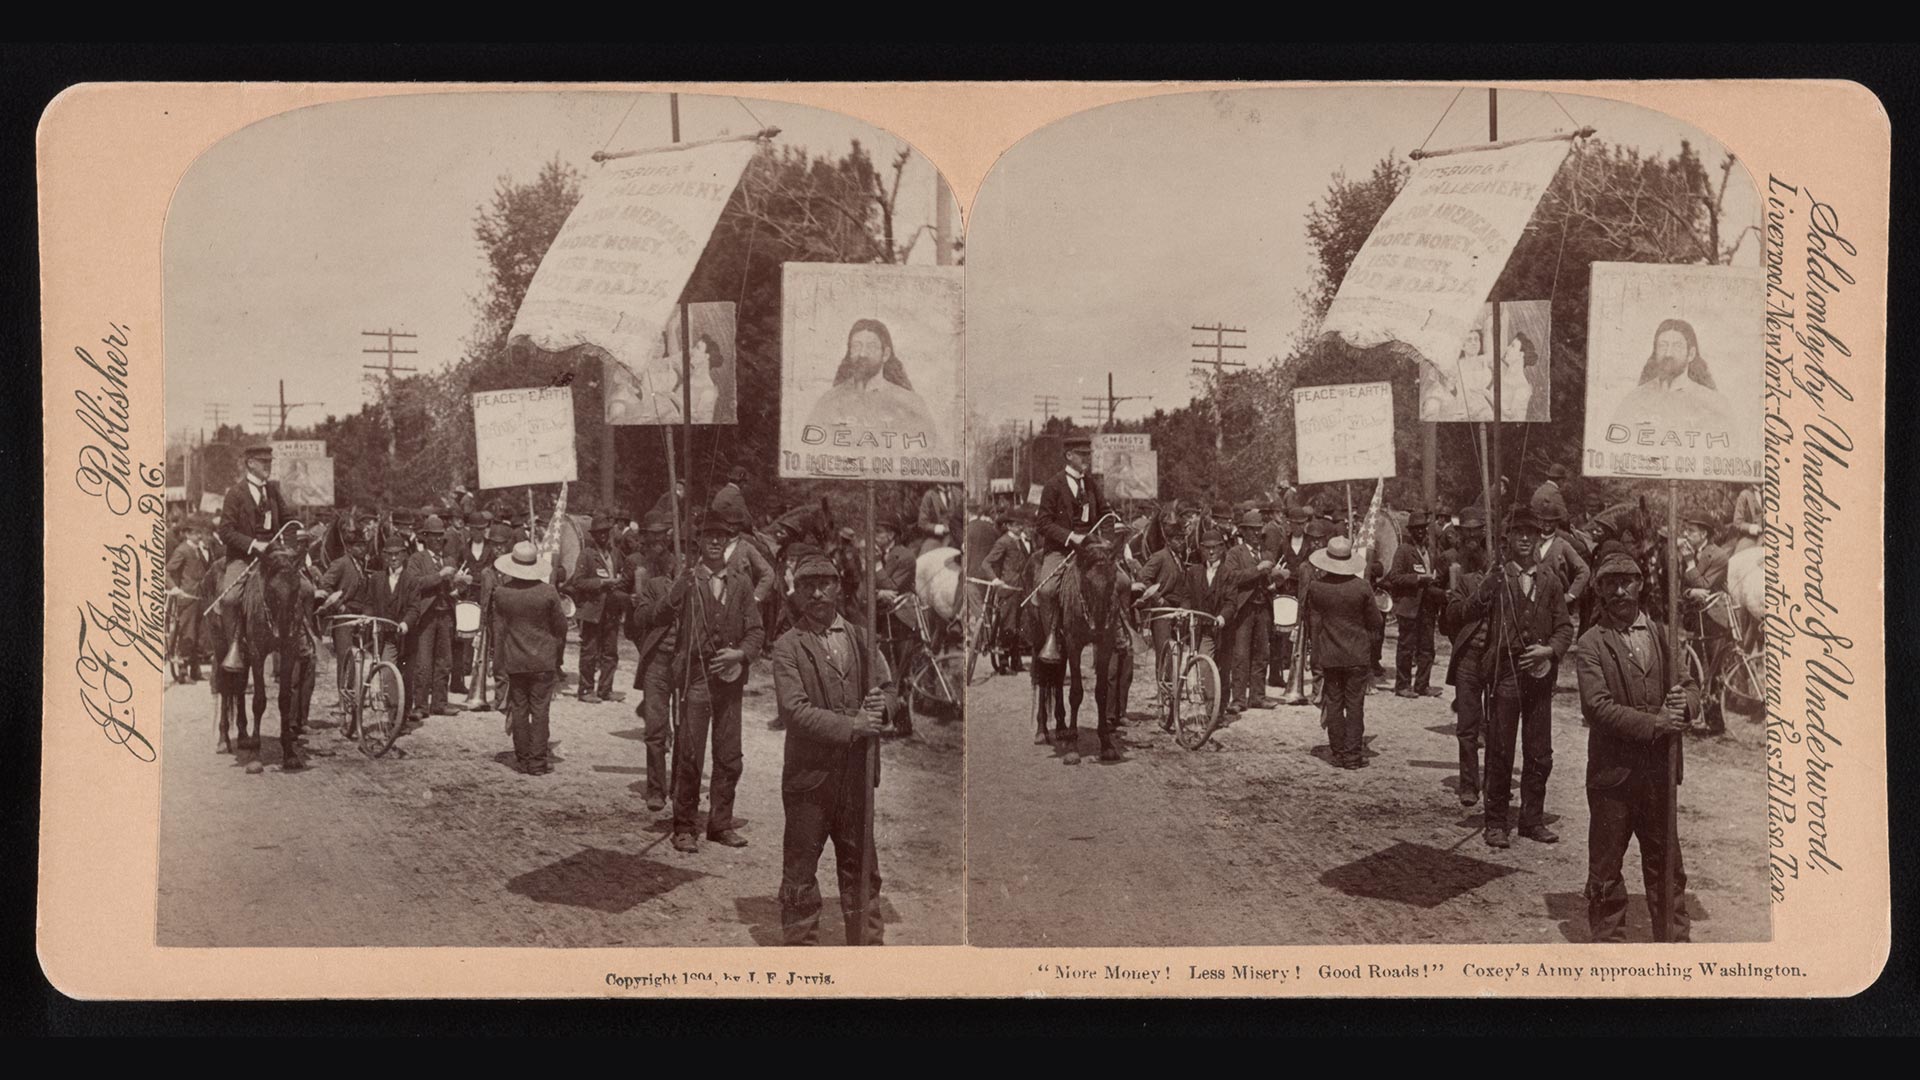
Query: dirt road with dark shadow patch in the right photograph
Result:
<box><xmin>968</xmin><ymin>640</ymin><xmax>1770</xmax><ymax>945</ymax></box>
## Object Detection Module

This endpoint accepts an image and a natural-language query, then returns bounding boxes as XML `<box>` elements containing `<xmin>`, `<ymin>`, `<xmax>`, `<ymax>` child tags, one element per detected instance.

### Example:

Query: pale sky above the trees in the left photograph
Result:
<box><xmin>163</xmin><ymin>92</ymin><xmax>944</xmax><ymax>441</ymax></box>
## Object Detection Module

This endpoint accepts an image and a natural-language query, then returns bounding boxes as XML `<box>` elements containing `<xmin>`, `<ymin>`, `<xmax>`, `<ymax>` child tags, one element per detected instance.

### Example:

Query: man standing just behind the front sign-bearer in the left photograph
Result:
<box><xmin>647</xmin><ymin>515</ymin><xmax>766</xmax><ymax>853</ymax></box>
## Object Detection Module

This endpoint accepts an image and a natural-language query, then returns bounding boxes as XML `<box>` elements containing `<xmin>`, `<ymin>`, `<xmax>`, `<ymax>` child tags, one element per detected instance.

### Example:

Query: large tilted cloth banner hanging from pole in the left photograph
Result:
<box><xmin>507</xmin><ymin>138</ymin><xmax>758</xmax><ymax>382</ymax></box>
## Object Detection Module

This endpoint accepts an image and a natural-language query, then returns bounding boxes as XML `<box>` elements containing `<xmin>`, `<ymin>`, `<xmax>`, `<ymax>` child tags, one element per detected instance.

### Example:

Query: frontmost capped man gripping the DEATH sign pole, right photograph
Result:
<box><xmin>1574</xmin><ymin>542</ymin><xmax>1699</xmax><ymax>942</ymax></box>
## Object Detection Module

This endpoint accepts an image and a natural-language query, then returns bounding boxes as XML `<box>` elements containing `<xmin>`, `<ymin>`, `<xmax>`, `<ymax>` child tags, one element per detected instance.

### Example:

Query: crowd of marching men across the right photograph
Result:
<box><xmin>968</xmin><ymin>438</ymin><xmax>1761</xmax><ymax>940</ymax></box>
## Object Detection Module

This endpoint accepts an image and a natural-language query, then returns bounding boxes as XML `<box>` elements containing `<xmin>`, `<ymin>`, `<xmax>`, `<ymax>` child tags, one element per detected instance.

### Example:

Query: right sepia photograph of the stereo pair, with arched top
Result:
<box><xmin>960</xmin><ymin>86</ymin><xmax>1772</xmax><ymax>947</ymax></box>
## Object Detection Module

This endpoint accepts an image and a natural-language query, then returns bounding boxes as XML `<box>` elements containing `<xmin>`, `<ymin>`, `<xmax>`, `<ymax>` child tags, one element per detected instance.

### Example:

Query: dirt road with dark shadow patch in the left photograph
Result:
<box><xmin>159</xmin><ymin>646</ymin><xmax>962</xmax><ymax>947</ymax></box>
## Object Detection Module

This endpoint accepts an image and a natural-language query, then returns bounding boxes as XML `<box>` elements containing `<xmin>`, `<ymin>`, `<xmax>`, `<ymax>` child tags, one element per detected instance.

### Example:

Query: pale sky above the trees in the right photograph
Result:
<box><xmin>966</xmin><ymin>86</ymin><xmax>1759</xmax><ymax>427</ymax></box>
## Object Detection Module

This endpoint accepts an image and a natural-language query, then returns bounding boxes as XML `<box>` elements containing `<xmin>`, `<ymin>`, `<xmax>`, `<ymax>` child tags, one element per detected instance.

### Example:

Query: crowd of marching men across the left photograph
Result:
<box><xmin>167</xmin><ymin>442</ymin><xmax>962</xmax><ymax>944</ymax></box>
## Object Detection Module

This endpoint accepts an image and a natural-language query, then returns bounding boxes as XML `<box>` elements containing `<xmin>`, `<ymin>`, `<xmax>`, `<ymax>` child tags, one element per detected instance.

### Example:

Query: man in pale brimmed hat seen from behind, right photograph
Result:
<box><xmin>1306</xmin><ymin>536</ymin><xmax>1384</xmax><ymax>769</ymax></box>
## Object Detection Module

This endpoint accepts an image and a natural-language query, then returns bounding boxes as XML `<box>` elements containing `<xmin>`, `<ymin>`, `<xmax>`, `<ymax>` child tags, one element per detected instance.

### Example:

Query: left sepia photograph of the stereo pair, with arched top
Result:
<box><xmin>157</xmin><ymin>90</ymin><xmax>970</xmax><ymax>947</ymax></box>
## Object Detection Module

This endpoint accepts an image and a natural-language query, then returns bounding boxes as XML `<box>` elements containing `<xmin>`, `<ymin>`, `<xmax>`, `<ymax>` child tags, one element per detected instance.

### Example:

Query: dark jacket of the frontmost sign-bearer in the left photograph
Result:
<box><xmin>774</xmin><ymin>619</ymin><xmax>893</xmax><ymax>794</ymax></box>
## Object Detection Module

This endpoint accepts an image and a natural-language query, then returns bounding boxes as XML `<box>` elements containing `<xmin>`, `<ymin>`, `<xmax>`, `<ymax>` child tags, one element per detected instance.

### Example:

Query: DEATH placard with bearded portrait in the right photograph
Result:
<box><xmin>1582</xmin><ymin>263</ymin><xmax>1766</xmax><ymax>480</ymax></box>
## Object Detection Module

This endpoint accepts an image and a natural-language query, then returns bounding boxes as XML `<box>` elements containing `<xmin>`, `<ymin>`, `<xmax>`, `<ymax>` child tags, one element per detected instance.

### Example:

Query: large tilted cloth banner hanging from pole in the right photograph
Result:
<box><xmin>1302</xmin><ymin>138</ymin><xmax>1572</xmax><ymax>368</ymax></box>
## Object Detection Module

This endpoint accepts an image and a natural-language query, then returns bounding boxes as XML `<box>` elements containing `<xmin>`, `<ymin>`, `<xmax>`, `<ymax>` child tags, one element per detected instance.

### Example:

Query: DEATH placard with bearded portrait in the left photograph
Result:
<box><xmin>780</xmin><ymin>263</ymin><xmax>966</xmax><ymax>482</ymax></box>
